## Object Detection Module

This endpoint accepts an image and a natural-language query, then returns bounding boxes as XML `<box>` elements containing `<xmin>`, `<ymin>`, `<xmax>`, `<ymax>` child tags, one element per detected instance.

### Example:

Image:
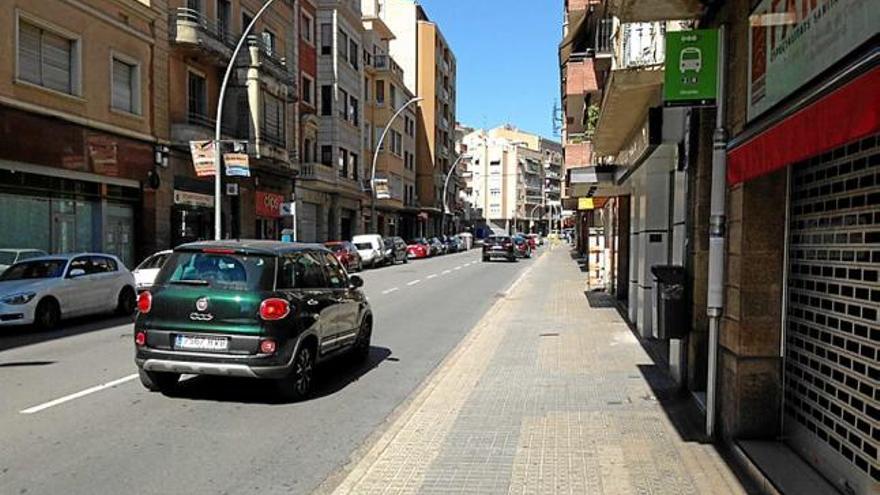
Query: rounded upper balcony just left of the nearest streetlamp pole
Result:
<box><xmin>169</xmin><ymin>8</ymin><xmax>238</xmax><ymax>64</ymax></box>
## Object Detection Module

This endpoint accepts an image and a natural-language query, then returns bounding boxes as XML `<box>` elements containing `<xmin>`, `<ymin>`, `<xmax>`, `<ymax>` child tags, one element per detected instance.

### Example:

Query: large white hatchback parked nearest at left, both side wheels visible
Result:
<box><xmin>0</xmin><ymin>253</ymin><xmax>136</xmax><ymax>329</ymax></box>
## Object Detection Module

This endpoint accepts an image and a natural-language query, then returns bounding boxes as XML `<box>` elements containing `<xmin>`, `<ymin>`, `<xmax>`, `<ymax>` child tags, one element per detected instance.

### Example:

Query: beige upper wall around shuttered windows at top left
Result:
<box><xmin>0</xmin><ymin>0</ymin><xmax>165</xmax><ymax>138</ymax></box>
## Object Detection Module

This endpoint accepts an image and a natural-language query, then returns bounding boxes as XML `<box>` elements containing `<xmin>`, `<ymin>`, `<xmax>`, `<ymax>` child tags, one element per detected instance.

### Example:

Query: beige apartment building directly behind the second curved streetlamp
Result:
<box><xmin>361</xmin><ymin>0</ymin><xmax>419</xmax><ymax>238</ymax></box>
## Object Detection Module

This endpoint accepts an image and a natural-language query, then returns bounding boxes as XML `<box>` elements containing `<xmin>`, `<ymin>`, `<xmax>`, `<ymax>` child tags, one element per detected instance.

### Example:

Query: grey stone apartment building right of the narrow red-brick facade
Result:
<box><xmin>297</xmin><ymin>0</ymin><xmax>369</xmax><ymax>241</ymax></box>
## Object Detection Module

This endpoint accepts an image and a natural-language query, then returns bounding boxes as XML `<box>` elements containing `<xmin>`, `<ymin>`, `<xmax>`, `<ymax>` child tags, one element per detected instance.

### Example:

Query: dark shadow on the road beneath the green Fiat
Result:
<box><xmin>169</xmin><ymin>346</ymin><xmax>396</xmax><ymax>405</ymax></box>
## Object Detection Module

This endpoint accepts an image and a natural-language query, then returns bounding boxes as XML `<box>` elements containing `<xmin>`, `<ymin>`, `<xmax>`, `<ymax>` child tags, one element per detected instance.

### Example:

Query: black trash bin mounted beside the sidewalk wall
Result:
<box><xmin>651</xmin><ymin>265</ymin><xmax>690</xmax><ymax>339</ymax></box>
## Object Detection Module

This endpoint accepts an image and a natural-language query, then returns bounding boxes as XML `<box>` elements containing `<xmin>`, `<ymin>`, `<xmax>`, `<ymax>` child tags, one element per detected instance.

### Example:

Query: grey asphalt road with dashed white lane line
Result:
<box><xmin>0</xmin><ymin>250</ymin><xmax>531</xmax><ymax>495</ymax></box>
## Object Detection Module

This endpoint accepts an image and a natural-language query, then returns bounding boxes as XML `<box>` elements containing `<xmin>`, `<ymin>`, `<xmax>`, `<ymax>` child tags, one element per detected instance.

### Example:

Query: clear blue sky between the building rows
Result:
<box><xmin>420</xmin><ymin>0</ymin><xmax>563</xmax><ymax>139</ymax></box>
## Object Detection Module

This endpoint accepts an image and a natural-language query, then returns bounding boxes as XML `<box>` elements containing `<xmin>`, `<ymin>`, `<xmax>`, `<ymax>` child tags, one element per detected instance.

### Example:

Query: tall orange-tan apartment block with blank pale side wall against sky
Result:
<box><xmin>380</xmin><ymin>0</ymin><xmax>461</xmax><ymax>235</ymax></box>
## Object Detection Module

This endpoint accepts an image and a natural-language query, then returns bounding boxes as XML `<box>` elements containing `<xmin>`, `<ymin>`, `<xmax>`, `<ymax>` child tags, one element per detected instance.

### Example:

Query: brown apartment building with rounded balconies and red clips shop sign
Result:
<box><xmin>165</xmin><ymin>0</ymin><xmax>298</xmax><ymax>245</ymax></box>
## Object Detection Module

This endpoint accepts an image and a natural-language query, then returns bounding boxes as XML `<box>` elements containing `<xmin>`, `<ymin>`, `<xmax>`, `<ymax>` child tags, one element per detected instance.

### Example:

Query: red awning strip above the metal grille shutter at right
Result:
<box><xmin>727</xmin><ymin>68</ymin><xmax>880</xmax><ymax>185</ymax></box>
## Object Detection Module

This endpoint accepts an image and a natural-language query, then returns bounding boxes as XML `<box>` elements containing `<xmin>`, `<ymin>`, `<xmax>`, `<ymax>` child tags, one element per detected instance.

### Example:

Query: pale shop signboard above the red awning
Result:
<box><xmin>748</xmin><ymin>0</ymin><xmax>880</xmax><ymax>120</ymax></box>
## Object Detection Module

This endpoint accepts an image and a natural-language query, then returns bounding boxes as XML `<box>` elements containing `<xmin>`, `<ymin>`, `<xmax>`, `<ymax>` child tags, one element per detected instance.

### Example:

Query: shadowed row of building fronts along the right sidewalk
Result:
<box><xmin>560</xmin><ymin>0</ymin><xmax>880</xmax><ymax>493</ymax></box>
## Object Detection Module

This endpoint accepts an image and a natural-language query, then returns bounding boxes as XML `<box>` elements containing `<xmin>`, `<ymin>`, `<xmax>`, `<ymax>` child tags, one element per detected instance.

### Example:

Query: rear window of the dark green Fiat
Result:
<box><xmin>156</xmin><ymin>251</ymin><xmax>275</xmax><ymax>291</ymax></box>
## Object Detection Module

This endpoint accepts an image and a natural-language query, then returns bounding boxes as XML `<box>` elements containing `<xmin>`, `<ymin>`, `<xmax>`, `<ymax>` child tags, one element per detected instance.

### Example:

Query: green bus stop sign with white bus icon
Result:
<box><xmin>663</xmin><ymin>29</ymin><xmax>718</xmax><ymax>106</ymax></box>
